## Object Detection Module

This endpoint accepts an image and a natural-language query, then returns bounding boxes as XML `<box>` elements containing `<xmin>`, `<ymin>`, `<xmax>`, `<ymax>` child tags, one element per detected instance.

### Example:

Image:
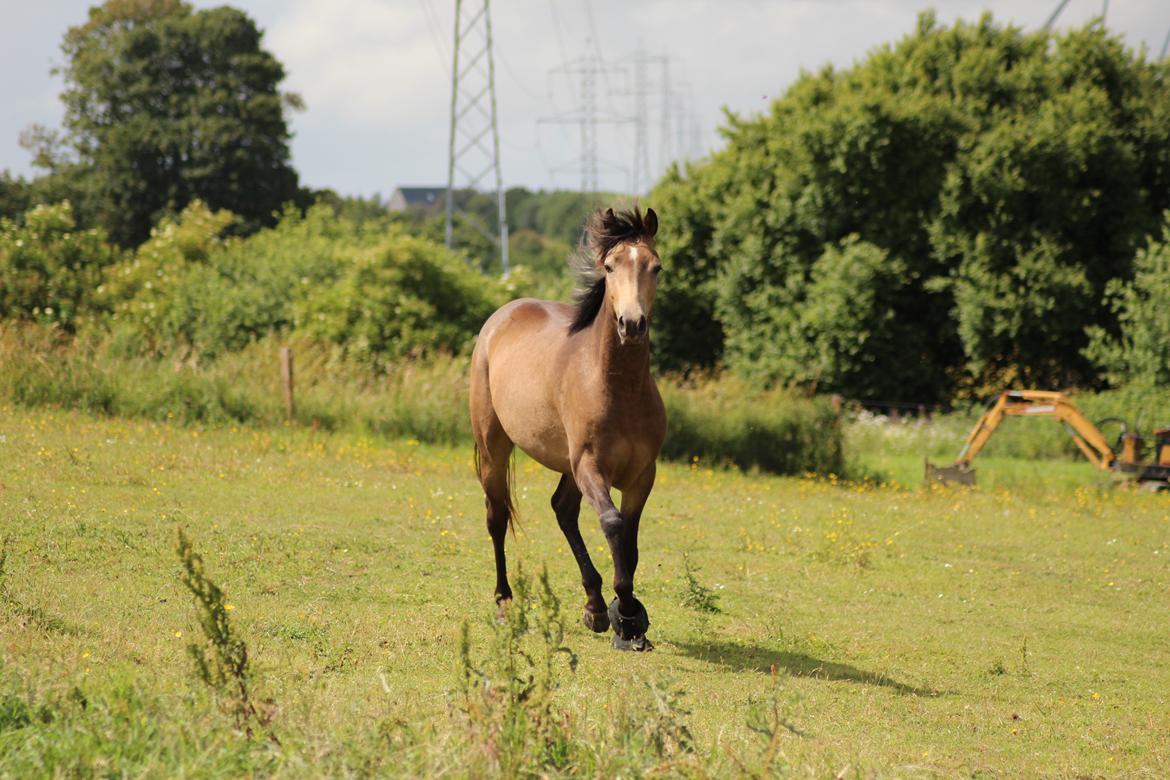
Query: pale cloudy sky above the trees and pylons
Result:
<box><xmin>0</xmin><ymin>0</ymin><xmax>1170</xmax><ymax>196</ymax></box>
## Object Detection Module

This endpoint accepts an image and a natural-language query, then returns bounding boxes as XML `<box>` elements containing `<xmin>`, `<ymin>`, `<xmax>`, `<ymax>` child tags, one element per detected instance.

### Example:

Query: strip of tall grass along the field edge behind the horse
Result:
<box><xmin>0</xmin><ymin>324</ymin><xmax>844</xmax><ymax>474</ymax></box>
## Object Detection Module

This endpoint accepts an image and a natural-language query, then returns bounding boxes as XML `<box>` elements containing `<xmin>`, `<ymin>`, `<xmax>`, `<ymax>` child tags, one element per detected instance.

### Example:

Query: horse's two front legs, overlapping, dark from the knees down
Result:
<box><xmin>574</xmin><ymin>458</ymin><xmax>654</xmax><ymax>650</ymax></box>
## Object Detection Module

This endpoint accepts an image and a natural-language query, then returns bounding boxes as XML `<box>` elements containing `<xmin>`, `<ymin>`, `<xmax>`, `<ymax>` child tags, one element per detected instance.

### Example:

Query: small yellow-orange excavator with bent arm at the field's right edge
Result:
<box><xmin>927</xmin><ymin>391</ymin><xmax>1170</xmax><ymax>490</ymax></box>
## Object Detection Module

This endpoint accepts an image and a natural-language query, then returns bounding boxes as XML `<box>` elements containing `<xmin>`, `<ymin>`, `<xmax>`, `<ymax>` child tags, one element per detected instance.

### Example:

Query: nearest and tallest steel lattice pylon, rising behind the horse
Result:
<box><xmin>446</xmin><ymin>0</ymin><xmax>509</xmax><ymax>276</ymax></box>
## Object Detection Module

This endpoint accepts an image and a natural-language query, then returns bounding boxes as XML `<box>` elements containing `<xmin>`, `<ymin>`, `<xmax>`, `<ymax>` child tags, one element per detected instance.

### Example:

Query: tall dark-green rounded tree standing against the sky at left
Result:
<box><xmin>50</xmin><ymin>0</ymin><xmax>300</xmax><ymax>244</ymax></box>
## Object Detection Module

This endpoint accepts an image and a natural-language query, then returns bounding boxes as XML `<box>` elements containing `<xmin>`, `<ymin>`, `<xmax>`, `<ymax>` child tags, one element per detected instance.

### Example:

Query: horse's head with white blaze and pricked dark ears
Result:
<box><xmin>596</xmin><ymin>207</ymin><xmax>662</xmax><ymax>344</ymax></box>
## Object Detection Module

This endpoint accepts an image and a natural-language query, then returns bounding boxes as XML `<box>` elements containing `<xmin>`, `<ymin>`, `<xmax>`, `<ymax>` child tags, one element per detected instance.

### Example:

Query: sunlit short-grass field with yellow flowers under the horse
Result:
<box><xmin>0</xmin><ymin>407</ymin><xmax>1170</xmax><ymax>778</ymax></box>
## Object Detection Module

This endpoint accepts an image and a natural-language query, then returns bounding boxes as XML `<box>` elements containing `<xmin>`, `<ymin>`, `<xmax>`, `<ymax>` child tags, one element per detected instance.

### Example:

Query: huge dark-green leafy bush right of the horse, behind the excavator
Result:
<box><xmin>655</xmin><ymin>14</ymin><xmax>1170</xmax><ymax>401</ymax></box>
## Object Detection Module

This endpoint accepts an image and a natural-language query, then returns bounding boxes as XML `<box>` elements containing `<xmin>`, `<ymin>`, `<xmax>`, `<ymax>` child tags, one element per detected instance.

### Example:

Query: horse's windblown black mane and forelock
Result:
<box><xmin>569</xmin><ymin>205</ymin><xmax>658</xmax><ymax>333</ymax></box>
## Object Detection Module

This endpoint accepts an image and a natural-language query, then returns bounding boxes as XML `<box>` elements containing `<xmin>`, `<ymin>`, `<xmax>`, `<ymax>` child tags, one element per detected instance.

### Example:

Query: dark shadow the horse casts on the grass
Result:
<box><xmin>673</xmin><ymin>641</ymin><xmax>943</xmax><ymax>696</ymax></box>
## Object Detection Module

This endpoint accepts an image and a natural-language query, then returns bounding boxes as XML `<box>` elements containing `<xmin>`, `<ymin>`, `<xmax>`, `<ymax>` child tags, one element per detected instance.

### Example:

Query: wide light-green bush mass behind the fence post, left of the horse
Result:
<box><xmin>102</xmin><ymin>201</ymin><xmax>503</xmax><ymax>363</ymax></box>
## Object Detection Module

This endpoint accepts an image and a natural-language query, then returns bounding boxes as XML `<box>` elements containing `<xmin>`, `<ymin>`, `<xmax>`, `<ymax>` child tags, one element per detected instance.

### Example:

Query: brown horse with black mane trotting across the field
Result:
<box><xmin>470</xmin><ymin>205</ymin><xmax>666</xmax><ymax>651</ymax></box>
